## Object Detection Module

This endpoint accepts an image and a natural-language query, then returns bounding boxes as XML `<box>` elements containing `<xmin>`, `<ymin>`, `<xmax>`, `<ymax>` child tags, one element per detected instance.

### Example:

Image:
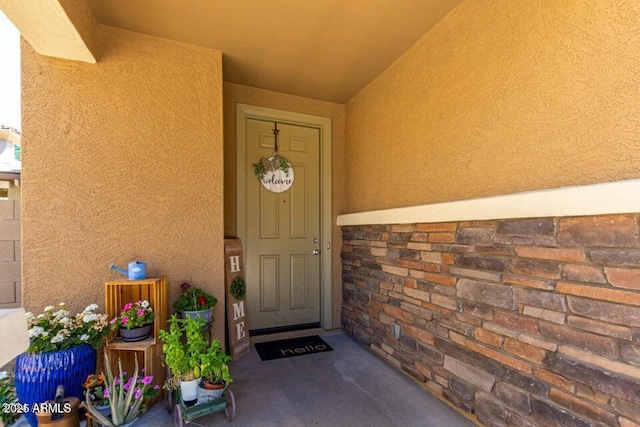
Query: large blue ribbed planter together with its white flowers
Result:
<box><xmin>15</xmin><ymin>303</ymin><xmax>109</xmax><ymax>426</ymax></box>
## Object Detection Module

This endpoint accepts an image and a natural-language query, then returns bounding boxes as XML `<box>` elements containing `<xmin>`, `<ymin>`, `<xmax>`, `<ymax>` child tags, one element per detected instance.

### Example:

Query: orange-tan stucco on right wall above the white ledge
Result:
<box><xmin>344</xmin><ymin>0</ymin><xmax>640</xmax><ymax>212</ymax></box>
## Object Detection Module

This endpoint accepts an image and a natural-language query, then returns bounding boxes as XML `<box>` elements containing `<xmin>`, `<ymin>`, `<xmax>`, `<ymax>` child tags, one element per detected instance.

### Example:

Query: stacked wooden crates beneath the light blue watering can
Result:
<box><xmin>105</xmin><ymin>277</ymin><xmax>168</xmax><ymax>398</ymax></box>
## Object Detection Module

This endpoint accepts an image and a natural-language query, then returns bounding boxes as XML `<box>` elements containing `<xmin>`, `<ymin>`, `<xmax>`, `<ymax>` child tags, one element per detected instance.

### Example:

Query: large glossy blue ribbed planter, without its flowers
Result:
<box><xmin>15</xmin><ymin>344</ymin><xmax>96</xmax><ymax>427</ymax></box>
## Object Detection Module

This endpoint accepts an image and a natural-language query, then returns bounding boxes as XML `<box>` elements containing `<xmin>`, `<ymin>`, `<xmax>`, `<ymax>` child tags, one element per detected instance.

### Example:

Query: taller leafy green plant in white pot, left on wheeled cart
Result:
<box><xmin>158</xmin><ymin>314</ymin><xmax>208</xmax><ymax>404</ymax></box>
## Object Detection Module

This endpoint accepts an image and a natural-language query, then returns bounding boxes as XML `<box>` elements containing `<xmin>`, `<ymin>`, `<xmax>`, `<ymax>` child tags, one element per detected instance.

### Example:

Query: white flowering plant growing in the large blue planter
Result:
<box><xmin>26</xmin><ymin>303</ymin><xmax>109</xmax><ymax>353</ymax></box>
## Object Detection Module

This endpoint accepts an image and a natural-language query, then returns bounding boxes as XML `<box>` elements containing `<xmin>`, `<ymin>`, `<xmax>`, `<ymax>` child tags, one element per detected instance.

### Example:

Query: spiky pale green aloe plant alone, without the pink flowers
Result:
<box><xmin>86</xmin><ymin>353</ymin><xmax>147</xmax><ymax>427</ymax></box>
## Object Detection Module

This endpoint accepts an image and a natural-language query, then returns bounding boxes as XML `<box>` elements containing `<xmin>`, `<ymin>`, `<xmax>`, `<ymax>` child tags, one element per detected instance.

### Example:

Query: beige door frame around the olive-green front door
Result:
<box><xmin>236</xmin><ymin>103</ymin><xmax>333</xmax><ymax>329</ymax></box>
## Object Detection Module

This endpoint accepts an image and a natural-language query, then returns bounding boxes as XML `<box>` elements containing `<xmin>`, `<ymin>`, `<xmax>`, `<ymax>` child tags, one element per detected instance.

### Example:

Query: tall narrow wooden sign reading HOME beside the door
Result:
<box><xmin>224</xmin><ymin>239</ymin><xmax>251</xmax><ymax>360</ymax></box>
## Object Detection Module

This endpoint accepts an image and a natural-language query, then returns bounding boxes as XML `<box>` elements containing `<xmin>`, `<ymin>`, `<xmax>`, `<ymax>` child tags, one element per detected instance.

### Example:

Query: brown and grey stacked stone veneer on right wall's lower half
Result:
<box><xmin>342</xmin><ymin>214</ymin><xmax>640</xmax><ymax>427</ymax></box>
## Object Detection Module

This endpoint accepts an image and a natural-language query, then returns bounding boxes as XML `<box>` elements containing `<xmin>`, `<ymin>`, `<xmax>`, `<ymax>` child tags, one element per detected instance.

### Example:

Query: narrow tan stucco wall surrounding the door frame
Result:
<box><xmin>224</xmin><ymin>83</ymin><xmax>345</xmax><ymax>326</ymax></box>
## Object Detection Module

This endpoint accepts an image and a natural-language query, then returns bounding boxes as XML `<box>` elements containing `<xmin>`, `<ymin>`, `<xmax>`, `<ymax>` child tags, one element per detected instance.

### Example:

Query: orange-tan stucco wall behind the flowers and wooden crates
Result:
<box><xmin>22</xmin><ymin>26</ymin><xmax>224</xmax><ymax>337</ymax></box>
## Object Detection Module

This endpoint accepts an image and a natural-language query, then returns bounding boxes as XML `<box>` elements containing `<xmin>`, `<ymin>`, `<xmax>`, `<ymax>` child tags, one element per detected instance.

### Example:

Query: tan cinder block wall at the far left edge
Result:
<box><xmin>0</xmin><ymin>200</ymin><xmax>20</xmax><ymax>308</ymax></box>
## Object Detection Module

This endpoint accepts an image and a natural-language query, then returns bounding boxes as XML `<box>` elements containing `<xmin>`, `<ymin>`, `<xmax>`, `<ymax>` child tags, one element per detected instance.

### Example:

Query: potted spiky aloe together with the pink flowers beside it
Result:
<box><xmin>85</xmin><ymin>353</ymin><xmax>159</xmax><ymax>427</ymax></box>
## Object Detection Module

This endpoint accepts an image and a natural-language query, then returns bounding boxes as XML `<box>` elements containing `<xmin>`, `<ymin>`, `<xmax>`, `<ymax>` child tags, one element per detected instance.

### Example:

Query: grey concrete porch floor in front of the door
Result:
<box><xmin>137</xmin><ymin>332</ymin><xmax>474</xmax><ymax>427</ymax></box>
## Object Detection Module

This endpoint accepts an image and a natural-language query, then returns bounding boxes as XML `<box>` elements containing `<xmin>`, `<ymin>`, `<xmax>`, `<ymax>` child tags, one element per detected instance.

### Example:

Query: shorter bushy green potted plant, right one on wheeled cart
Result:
<box><xmin>198</xmin><ymin>339</ymin><xmax>233</xmax><ymax>403</ymax></box>
